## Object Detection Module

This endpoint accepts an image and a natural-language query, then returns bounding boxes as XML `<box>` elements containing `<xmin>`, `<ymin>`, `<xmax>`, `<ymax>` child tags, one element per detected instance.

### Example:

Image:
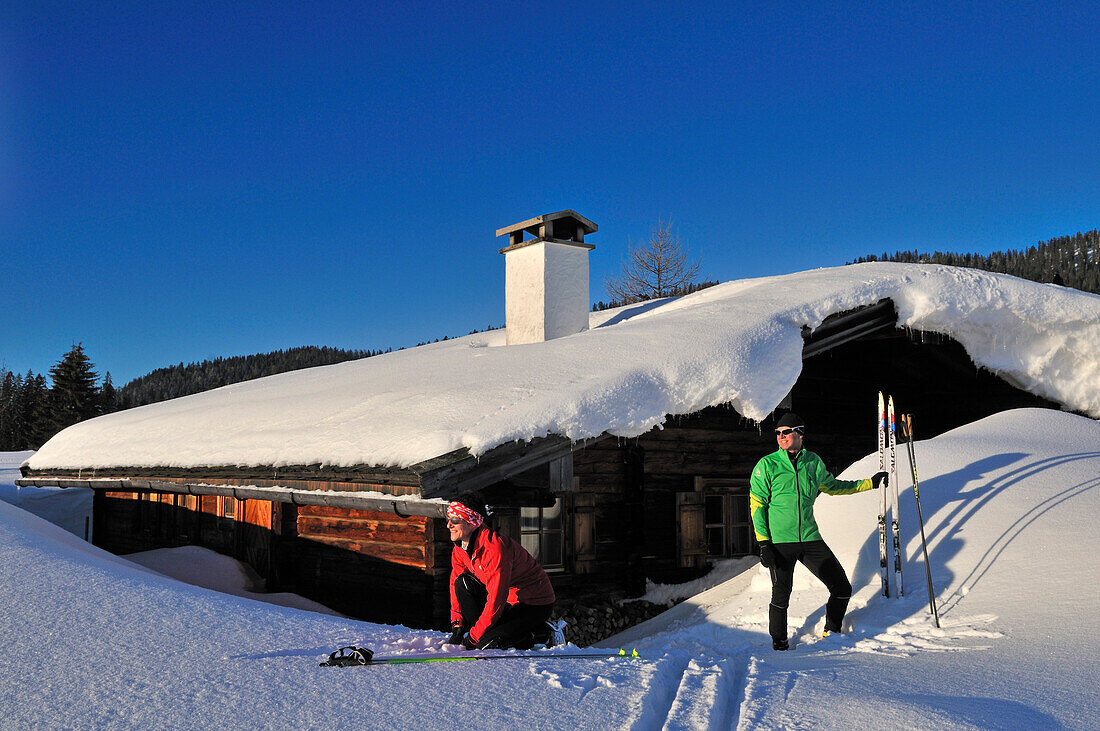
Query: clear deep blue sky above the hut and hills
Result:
<box><xmin>0</xmin><ymin>0</ymin><xmax>1100</xmax><ymax>385</ymax></box>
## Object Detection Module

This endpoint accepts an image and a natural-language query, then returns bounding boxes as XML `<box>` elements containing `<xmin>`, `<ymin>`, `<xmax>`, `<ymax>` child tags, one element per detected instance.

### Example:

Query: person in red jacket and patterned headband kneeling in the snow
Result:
<box><xmin>447</xmin><ymin>498</ymin><xmax>554</xmax><ymax>650</ymax></box>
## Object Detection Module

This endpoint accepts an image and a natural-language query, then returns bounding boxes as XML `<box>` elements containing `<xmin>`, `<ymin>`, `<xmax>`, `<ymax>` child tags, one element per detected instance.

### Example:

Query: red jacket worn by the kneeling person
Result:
<box><xmin>451</xmin><ymin>528</ymin><xmax>554</xmax><ymax>642</ymax></box>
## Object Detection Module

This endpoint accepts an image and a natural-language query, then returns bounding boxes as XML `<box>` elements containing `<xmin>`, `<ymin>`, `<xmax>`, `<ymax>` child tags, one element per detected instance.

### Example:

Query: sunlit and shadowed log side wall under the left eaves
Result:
<box><xmin>94</xmin><ymin>490</ymin><xmax>451</xmax><ymax>629</ymax></box>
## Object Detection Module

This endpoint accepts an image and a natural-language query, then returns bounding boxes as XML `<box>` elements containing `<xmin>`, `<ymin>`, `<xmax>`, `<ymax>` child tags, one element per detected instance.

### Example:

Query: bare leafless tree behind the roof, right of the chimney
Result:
<box><xmin>604</xmin><ymin>219</ymin><xmax>700</xmax><ymax>304</ymax></box>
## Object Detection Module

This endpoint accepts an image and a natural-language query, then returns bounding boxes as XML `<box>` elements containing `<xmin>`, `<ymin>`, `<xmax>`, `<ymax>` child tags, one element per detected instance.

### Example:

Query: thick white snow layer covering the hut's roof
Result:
<box><xmin>28</xmin><ymin>263</ymin><xmax>1100</xmax><ymax>470</ymax></box>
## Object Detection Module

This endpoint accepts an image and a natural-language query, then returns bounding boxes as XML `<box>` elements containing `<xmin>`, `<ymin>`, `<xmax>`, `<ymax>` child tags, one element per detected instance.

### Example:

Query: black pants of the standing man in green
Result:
<box><xmin>768</xmin><ymin>541</ymin><xmax>851</xmax><ymax>641</ymax></box>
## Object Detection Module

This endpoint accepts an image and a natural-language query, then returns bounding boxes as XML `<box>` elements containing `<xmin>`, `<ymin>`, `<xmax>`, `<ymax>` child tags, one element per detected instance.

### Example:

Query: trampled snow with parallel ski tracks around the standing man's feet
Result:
<box><xmin>633</xmin><ymin>562</ymin><xmax>1016</xmax><ymax>730</ymax></box>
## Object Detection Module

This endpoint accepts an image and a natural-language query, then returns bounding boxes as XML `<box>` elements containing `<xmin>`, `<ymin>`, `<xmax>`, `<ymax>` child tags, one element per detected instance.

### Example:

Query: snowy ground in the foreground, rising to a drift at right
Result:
<box><xmin>0</xmin><ymin>409</ymin><xmax>1100</xmax><ymax>729</ymax></box>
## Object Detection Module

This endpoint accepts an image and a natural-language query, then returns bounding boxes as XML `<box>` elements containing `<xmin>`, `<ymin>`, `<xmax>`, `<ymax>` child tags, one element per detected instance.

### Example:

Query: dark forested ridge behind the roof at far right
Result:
<box><xmin>856</xmin><ymin>230</ymin><xmax>1100</xmax><ymax>295</ymax></box>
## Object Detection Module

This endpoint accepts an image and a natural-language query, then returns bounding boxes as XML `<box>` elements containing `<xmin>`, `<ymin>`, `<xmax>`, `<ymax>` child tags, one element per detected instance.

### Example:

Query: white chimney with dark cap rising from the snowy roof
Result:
<box><xmin>496</xmin><ymin>210</ymin><xmax>597</xmax><ymax>345</ymax></box>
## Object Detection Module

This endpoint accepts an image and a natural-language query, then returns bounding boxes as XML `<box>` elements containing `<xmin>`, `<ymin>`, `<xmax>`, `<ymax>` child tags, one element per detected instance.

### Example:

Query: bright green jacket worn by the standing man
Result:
<box><xmin>749</xmin><ymin>450</ymin><xmax>875</xmax><ymax>543</ymax></box>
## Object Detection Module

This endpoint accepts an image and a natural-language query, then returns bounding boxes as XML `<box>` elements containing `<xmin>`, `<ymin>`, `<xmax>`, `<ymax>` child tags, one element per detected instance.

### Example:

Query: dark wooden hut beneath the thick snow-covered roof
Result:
<box><xmin>19</xmin><ymin>300</ymin><xmax>1058</xmax><ymax>628</ymax></box>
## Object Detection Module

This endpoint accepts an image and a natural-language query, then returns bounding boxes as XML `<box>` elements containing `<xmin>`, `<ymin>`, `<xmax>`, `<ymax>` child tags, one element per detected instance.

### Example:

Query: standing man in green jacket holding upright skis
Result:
<box><xmin>749</xmin><ymin>413</ymin><xmax>887</xmax><ymax>650</ymax></box>
